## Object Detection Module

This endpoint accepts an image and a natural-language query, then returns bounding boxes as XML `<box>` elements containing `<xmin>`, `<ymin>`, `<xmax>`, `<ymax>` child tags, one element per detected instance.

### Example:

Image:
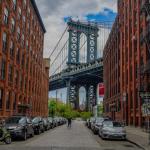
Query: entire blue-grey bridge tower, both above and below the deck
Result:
<box><xmin>66</xmin><ymin>19</ymin><xmax>99</xmax><ymax>111</ymax></box>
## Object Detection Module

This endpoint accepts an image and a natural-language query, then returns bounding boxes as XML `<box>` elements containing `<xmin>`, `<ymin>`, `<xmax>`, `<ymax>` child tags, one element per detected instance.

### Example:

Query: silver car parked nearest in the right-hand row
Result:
<box><xmin>98</xmin><ymin>121</ymin><xmax>126</xmax><ymax>140</ymax></box>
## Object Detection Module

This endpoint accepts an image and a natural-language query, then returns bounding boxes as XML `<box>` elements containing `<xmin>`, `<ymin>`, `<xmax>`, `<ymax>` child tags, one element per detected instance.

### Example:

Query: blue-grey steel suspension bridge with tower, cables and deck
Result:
<box><xmin>49</xmin><ymin>19</ymin><xmax>113</xmax><ymax>110</ymax></box>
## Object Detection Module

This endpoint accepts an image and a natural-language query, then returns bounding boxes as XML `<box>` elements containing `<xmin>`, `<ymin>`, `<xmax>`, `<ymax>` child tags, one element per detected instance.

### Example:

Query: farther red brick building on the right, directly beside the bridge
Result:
<box><xmin>103</xmin><ymin>17</ymin><xmax>121</xmax><ymax>120</ymax></box>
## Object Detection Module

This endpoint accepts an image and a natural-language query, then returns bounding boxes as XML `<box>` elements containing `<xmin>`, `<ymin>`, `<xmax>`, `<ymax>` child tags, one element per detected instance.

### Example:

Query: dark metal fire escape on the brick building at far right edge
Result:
<box><xmin>140</xmin><ymin>0</ymin><xmax>150</xmax><ymax>92</ymax></box>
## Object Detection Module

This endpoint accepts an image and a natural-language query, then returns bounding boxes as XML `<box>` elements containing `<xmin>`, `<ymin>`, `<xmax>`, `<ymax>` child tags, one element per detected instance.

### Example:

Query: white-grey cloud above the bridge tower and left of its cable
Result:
<box><xmin>36</xmin><ymin>0</ymin><xmax>117</xmax><ymax>57</ymax></box>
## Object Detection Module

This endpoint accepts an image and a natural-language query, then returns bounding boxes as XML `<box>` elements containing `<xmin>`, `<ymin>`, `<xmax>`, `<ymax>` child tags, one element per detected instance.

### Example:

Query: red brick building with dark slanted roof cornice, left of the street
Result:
<box><xmin>0</xmin><ymin>0</ymin><xmax>49</xmax><ymax>117</ymax></box>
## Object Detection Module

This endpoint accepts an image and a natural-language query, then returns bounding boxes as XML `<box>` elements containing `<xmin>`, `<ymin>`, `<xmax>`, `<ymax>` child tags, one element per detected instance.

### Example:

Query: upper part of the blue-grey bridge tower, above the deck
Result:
<box><xmin>67</xmin><ymin>19</ymin><xmax>99</xmax><ymax>65</ymax></box>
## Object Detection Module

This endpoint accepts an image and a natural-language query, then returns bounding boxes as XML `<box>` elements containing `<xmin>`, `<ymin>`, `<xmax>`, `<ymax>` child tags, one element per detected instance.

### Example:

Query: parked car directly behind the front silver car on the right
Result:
<box><xmin>91</xmin><ymin>117</ymin><xmax>110</xmax><ymax>134</ymax></box>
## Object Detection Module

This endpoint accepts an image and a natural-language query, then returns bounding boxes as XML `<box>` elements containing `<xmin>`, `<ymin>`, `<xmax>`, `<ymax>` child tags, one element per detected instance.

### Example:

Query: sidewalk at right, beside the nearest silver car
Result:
<box><xmin>126</xmin><ymin>126</ymin><xmax>150</xmax><ymax>150</ymax></box>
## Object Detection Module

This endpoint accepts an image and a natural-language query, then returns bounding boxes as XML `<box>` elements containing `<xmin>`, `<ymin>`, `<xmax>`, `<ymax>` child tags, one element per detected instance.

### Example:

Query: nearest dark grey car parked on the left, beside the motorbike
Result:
<box><xmin>5</xmin><ymin>116</ymin><xmax>34</xmax><ymax>140</ymax></box>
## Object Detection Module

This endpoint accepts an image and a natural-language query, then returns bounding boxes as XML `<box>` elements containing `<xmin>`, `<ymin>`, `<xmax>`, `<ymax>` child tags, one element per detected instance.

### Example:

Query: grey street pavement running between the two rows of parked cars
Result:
<box><xmin>0</xmin><ymin>121</ymin><xmax>143</xmax><ymax>150</ymax></box>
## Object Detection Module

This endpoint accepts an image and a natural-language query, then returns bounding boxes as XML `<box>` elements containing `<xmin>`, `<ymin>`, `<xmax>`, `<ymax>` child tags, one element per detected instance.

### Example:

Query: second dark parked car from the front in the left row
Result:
<box><xmin>32</xmin><ymin>117</ymin><xmax>45</xmax><ymax>134</ymax></box>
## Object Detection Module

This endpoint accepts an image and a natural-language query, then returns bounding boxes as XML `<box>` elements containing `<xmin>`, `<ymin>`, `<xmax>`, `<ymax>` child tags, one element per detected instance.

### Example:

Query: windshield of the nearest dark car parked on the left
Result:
<box><xmin>6</xmin><ymin>117</ymin><xmax>25</xmax><ymax>124</ymax></box>
